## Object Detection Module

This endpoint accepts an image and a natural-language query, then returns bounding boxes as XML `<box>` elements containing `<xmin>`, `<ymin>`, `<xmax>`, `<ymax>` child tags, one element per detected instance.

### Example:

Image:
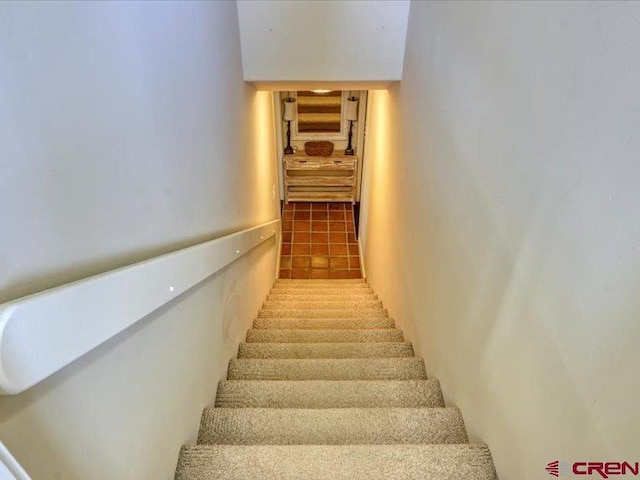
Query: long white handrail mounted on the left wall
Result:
<box><xmin>0</xmin><ymin>220</ymin><xmax>280</xmax><ymax>395</ymax></box>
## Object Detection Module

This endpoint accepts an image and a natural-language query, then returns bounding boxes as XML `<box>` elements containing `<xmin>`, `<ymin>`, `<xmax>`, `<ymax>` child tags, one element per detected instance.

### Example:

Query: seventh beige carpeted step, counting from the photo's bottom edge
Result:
<box><xmin>253</xmin><ymin>317</ymin><xmax>396</xmax><ymax>330</ymax></box>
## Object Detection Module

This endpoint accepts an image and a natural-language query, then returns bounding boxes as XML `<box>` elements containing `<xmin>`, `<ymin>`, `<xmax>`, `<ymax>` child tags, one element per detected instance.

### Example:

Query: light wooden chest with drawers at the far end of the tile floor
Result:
<box><xmin>283</xmin><ymin>152</ymin><xmax>358</xmax><ymax>203</ymax></box>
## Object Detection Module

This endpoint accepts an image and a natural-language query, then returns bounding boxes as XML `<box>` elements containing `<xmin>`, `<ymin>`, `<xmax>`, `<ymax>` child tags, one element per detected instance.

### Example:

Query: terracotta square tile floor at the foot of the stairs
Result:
<box><xmin>280</xmin><ymin>202</ymin><xmax>362</xmax><ymax>278</ymax></box>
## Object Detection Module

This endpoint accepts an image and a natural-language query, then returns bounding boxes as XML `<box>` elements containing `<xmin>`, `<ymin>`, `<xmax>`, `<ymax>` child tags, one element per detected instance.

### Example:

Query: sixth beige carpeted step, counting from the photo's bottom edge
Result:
<box><xmin>247</xmin><ymin>328</ymin><xmax>404</xmax><ymax>343</ymax></box>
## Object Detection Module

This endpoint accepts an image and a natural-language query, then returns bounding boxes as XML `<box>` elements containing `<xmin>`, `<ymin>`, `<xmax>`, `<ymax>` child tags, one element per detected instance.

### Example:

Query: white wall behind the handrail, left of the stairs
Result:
<box><xmin>0</xmin><ymin>2</ymin><xmax>278</xmax><ymax>480</ymax></box>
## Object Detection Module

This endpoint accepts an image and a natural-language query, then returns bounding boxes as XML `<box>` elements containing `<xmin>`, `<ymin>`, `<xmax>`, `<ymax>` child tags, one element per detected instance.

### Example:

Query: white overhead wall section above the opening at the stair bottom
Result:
<box><xmin>237</xmin><ymin>0</ymin><xmax>409</xmax><ymax>83</ymax></box>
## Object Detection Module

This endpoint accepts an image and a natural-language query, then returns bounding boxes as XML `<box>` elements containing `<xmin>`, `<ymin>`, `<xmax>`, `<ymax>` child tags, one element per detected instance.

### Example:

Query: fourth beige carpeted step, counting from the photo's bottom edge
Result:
<box><xmin>227</xmin><ymin>357</ymin><xmax>427</xmax><ymax>380</ymax></box>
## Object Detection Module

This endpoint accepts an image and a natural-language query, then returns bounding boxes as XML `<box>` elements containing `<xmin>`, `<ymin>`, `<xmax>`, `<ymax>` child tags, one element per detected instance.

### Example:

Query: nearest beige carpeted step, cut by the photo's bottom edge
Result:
<box><xmin>175</xmin><ymin>444</ymin><xmax>498</xmax><ymax>480</ymax></box>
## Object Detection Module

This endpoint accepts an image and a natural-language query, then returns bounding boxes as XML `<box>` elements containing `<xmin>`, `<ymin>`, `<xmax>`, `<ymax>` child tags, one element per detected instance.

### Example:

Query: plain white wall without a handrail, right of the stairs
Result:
<box><xmin>362</xmin><ymin>2</ymin><xmax>640</xmax><ymax>479</ymax></box>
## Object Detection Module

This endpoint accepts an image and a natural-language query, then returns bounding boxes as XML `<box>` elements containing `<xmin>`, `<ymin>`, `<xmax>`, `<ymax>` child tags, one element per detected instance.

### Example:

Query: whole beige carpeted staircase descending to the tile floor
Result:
<box><xmin>175</xmin><ymin>280</ymin><xmax>497</xmax><ymax>480</ymax></box>
